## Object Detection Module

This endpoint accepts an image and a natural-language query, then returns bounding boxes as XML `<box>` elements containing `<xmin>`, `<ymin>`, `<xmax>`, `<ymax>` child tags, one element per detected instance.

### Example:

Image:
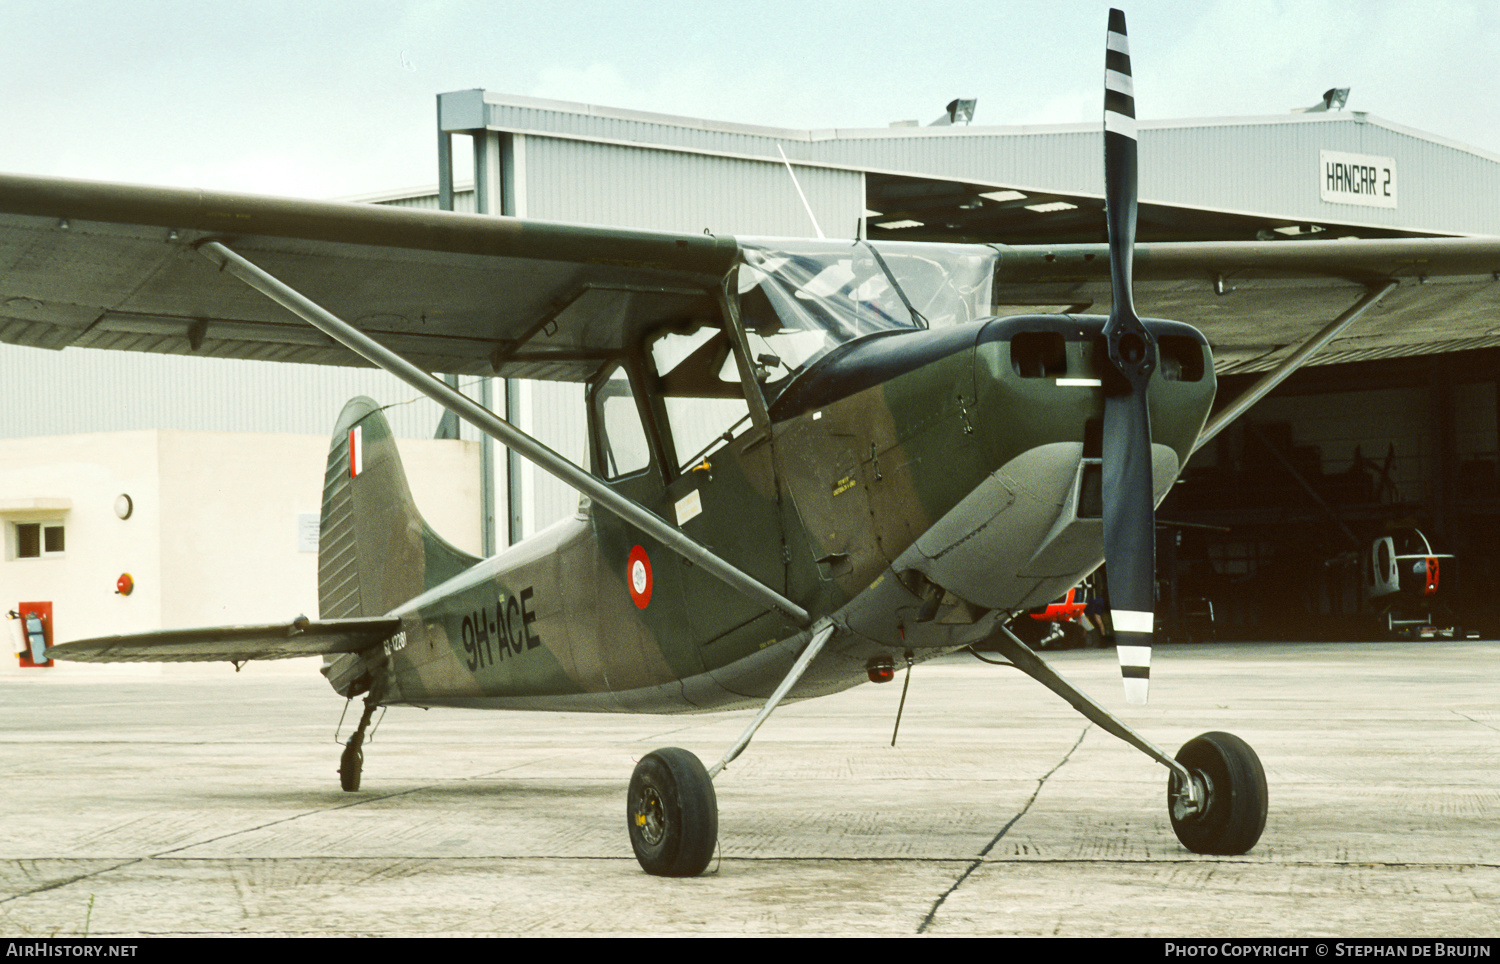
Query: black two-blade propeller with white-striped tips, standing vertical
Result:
<box><xmin>1101</xmin><ymin>10</ymin><xmax>1157</xmax><ymax>703</ymax></box>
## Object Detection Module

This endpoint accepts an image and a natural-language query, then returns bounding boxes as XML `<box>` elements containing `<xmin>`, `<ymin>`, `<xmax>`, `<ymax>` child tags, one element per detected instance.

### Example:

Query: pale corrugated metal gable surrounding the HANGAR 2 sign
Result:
<box><xmin>816</xmin><ymin>114</ymin><xmax>1500</xmax><ymax>234</ymax></box>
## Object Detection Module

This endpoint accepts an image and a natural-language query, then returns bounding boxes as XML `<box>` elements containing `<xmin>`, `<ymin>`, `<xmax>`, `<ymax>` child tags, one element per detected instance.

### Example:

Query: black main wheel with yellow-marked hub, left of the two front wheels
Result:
<box><xmin>626</xmin><ymin>747</ymin><xmax>719</xmax><ymax>877</ymax></box>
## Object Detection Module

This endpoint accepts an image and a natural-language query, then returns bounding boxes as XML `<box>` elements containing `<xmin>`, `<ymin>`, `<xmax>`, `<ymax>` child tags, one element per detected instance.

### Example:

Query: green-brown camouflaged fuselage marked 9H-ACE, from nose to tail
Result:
<box><xmin>331</xmin><ymin>315</ymin><xmax>1215</xmax><ymax>712</ymax></box>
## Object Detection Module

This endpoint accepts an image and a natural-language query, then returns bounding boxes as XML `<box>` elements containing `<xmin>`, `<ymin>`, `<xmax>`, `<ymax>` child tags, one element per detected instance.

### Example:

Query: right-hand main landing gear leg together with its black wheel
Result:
<box><xmin>990</xmin><ymin>627</ymin><xmax>1266</xmax><ymax>855</ymax></box>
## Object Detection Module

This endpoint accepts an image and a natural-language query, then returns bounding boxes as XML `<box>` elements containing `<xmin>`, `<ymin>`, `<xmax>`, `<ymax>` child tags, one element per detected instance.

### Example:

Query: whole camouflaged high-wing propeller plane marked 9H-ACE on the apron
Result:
<box><xmin>11</xmin><ymin>10</ymin><xmax>1500</xmax><ymax>876</ymax></box>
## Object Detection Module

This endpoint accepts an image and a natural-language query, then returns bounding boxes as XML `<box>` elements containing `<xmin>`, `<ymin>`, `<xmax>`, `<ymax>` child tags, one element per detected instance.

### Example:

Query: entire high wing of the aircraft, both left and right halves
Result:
<box><xmin>0</xmin><ymin>169</ymin><xmax>1500</xmax><ymax>381</ymax></box>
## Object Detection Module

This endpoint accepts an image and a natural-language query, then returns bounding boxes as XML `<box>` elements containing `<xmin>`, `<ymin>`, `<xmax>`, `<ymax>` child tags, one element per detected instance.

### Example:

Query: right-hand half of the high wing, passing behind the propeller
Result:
<box><xmin>996</xmin><ymin>237</ymin><xmax>1500</xmax><ymax>373</ymax></box>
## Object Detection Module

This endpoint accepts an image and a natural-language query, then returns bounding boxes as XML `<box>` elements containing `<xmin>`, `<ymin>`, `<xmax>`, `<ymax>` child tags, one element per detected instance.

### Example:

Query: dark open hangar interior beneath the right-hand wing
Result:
<box><xmin>1158</xmin><ymin>348</ymin><xmax>1500</xmax><ymax>640</ymax></box>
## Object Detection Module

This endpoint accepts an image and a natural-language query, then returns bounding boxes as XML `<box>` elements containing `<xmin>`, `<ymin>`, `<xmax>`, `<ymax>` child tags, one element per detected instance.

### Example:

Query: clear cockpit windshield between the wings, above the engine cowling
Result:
<box><xmin>740</xmin><ymin>238</ymin><xmax>996</xmax><ymax>402</ymax></box>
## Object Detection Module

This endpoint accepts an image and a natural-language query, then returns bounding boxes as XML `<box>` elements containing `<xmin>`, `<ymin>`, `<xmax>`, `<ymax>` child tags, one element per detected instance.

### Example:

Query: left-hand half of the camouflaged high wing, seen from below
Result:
<box><xmin>0</xmin><ymin>175</ymin><xmax>737</xmax><ymax>381</ymax></box>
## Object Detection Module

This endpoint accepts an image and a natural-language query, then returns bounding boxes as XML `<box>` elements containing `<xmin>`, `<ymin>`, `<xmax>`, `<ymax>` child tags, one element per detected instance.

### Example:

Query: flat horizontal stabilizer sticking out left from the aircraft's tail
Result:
<box><xmin>47</xmin><ymin>616</ymin><xmax>401</xmax><ymax>663</ymax></box>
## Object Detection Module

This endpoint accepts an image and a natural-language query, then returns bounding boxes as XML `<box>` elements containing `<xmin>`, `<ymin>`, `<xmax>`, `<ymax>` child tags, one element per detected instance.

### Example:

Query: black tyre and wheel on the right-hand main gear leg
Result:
<box><xmin>1167</xmin><ymin>733</ymin><xmax>1266</xmax><ymax>855</ymax></box>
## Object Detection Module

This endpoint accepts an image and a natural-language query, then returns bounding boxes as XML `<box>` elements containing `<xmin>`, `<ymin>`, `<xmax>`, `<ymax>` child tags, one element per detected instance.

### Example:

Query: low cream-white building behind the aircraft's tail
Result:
<box><xmin>0</xmin><ymin>430</ymin><xmax>479</xmax><ymax>669</ymax></box>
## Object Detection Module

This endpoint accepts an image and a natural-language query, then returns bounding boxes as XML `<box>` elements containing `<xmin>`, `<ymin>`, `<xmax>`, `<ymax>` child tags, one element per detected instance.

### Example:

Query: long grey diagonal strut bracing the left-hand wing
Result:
<box><xmin>198</xmin><ymin>241</ymin><xmax>813</xmax><ymax>630</ymax></box>
